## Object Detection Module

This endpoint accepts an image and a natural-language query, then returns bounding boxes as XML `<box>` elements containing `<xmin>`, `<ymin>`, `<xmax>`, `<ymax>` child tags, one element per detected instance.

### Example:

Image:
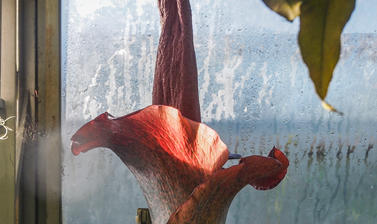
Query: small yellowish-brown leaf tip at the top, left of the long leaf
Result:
<box><xmin>263</xmin><ymin>0</ymin><xmax>302</xmax><ymax>21</ymax></box>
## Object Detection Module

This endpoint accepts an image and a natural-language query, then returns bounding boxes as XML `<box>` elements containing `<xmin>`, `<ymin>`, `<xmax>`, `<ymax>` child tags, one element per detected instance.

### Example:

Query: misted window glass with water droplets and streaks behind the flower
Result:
<box><xmin>62</xmin><ymin>0</ymin><xmax>377</xmax><ymax>224</ymax></box>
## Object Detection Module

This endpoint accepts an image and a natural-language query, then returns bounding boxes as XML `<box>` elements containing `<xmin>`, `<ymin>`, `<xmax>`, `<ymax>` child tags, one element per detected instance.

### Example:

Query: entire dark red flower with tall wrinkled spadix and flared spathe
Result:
<box><xmin>71</xmin><ymin>0</ymin><xmax>289</xmax><ymax>224</ymax></box>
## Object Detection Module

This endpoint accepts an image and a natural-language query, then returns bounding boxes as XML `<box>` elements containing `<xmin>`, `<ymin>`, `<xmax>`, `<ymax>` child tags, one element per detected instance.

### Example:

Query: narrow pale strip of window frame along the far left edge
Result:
<box><xmin>0</xmin><ymin>0</ymin><xmax>16</xmax><ymax>223</ymax></box>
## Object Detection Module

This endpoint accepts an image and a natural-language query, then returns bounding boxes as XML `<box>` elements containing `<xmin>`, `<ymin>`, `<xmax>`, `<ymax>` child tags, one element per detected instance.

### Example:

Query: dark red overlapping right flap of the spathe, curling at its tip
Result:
<box><xmin>168</xmin><ymin>148</ymin><xmax>288</xmax><ymax>224</ymax></box>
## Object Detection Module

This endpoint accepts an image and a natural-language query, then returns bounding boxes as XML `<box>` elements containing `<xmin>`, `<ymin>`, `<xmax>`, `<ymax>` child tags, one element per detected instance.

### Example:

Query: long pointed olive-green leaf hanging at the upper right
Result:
<box><xmin>298</xmin><ymin>0</ymin><xmax>355</xmax><ymax>100</ymax></box>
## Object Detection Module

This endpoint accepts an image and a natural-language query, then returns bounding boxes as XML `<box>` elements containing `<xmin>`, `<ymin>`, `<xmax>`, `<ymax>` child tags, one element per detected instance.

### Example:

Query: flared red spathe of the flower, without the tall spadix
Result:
<box><xmin>72</xmin><ymin>105</ymin><xmax>289</xmax><ymax>224</ymax></box>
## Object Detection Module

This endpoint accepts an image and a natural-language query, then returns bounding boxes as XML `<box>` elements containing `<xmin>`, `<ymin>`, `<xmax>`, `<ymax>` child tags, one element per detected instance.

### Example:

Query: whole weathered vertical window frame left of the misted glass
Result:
<box><xmin>0</xmin><ymin>0</ymin><xmax>62</xmax><ymax>224</ymax></box>
